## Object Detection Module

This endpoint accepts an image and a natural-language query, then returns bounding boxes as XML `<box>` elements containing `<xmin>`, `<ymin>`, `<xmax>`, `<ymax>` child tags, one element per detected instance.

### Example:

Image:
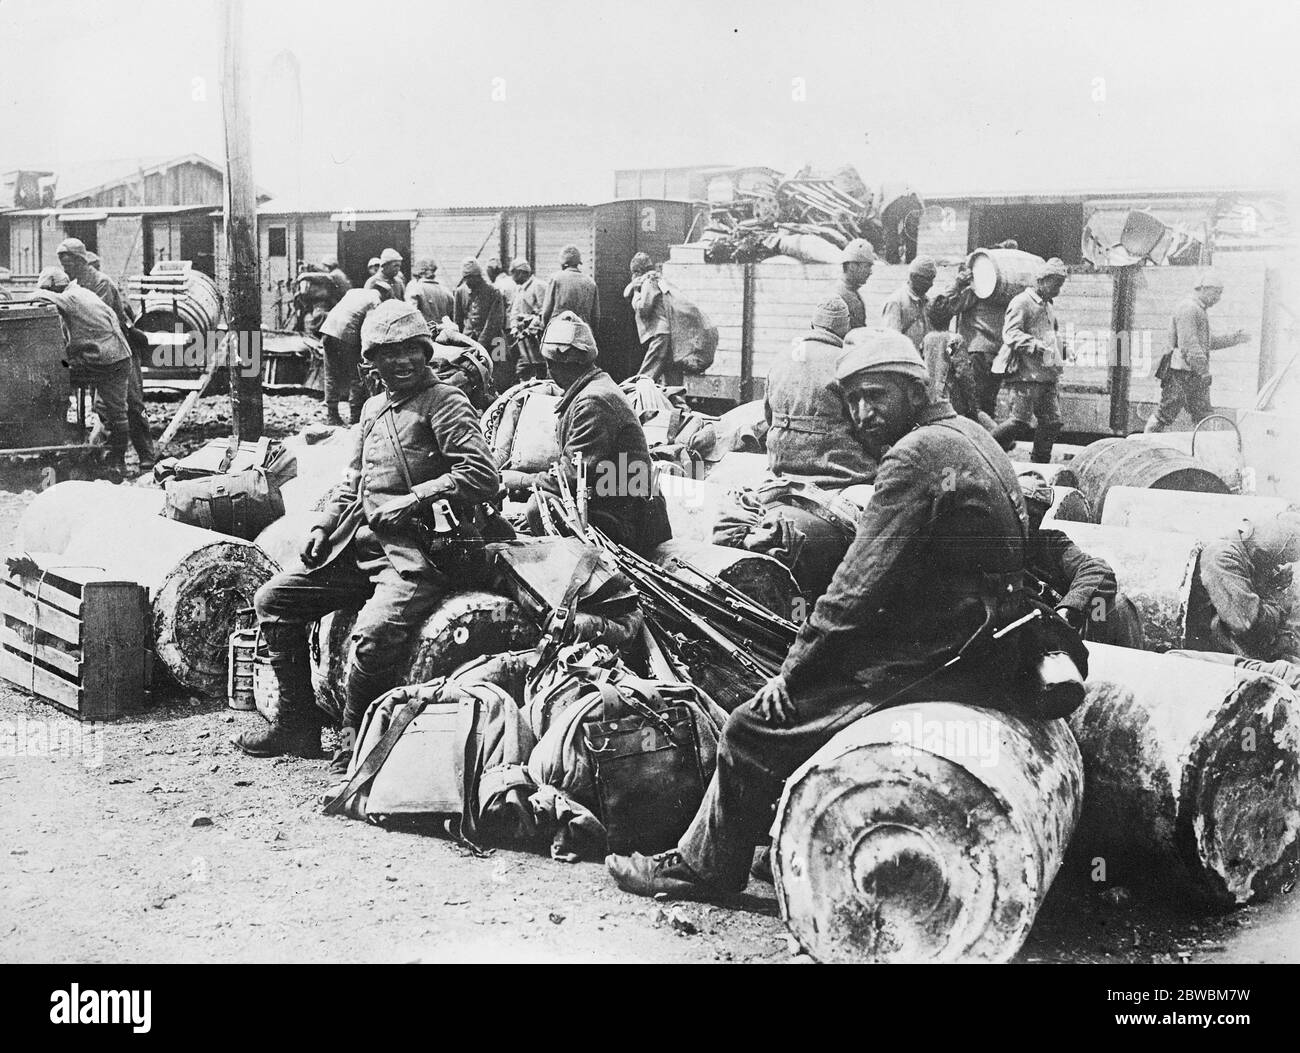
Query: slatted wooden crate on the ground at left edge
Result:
<box><xmin>0</xmin><ymin>554</ymin><xmax>151</xmax><ymax>720</ymax></box>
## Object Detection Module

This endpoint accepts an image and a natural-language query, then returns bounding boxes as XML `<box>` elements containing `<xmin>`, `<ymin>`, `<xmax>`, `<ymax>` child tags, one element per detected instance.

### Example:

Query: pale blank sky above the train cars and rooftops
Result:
<box><xmin>0</xmin><ymin>0</ymin><xmax>1300</xmax><ymax>209</ymax></box>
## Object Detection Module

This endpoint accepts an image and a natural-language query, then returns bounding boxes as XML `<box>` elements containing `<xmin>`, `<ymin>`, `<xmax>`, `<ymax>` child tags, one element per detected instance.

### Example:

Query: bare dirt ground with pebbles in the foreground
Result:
<box><xmin>0</xmin><ymin>399</ymin><xmax>1300</xmax><ymax>962</ymax></box>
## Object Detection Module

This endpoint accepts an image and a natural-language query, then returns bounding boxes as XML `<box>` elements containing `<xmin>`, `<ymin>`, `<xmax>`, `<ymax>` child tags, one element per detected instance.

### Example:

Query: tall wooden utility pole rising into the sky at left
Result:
<box><xmin>221</xmin><ymin>0</ymin><xmax>263</xmax><ymax>443</ymax></box>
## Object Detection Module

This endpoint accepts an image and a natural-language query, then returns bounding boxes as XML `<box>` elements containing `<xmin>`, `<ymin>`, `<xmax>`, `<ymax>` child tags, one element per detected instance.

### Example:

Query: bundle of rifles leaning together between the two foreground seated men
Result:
<box><xmin>537</xmin><ymin>462</ymin><xmax>798</xmax><ymax>712</ymax></box>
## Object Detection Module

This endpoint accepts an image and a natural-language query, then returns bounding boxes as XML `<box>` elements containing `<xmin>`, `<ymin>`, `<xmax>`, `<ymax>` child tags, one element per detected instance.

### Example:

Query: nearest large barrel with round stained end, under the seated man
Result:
<box><xmin>772</xmin><ymin>702</ymin><xmax>1083</xmax><ymax>962</ymax></box>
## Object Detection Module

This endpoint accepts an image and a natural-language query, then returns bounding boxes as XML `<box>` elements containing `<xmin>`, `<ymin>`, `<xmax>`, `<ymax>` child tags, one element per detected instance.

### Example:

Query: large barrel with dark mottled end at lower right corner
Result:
<box><xmin>1070</xmin><ymin>644</ymin><xmax>1300</xmax><ymax>906</ymax></box>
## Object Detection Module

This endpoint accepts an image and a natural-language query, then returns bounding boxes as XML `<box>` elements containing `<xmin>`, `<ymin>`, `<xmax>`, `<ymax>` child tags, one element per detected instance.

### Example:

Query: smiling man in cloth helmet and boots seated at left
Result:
<box><xmin>233</xmin><ymin>300</ymin><xmax>501</xmax><ymax>776</ymax></box>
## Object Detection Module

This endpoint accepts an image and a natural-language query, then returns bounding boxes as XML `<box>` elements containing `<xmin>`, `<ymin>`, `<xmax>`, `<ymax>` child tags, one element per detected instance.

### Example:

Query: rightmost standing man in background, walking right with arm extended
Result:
<box><xmin>1145</xmin><ymin>273</ymin><xmax>1251</xmax><ymax>432</ymax></box>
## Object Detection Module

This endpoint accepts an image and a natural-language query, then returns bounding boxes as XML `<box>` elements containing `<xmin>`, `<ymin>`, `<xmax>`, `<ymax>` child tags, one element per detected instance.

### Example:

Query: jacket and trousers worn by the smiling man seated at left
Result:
<box><xmin>255</xmin><ymin>371</ymin><xmax>501</xmax><ymax>729</ymax></box>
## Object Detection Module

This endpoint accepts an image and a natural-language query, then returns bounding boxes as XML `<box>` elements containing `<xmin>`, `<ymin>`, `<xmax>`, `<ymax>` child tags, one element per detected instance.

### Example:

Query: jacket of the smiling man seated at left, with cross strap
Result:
<box><xmin>313</xmin><ymin>369</ymin><xmax>501</xmax><ymax>575</ymax></box>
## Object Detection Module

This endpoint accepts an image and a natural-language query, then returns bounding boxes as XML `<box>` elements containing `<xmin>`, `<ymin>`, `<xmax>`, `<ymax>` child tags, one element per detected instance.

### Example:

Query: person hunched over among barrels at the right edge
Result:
<box><xmin>1197</xmin><ymin>512</ymin><xmax>1300</xmax><ymax>662</ymax></box>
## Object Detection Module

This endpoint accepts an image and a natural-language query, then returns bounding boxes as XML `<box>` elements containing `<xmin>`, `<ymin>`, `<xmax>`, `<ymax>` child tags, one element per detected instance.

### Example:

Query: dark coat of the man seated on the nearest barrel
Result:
<box><xmin>781</xmin><ymin>402</ymin><xmax>1027</xmax><ymax>705</ymax></box>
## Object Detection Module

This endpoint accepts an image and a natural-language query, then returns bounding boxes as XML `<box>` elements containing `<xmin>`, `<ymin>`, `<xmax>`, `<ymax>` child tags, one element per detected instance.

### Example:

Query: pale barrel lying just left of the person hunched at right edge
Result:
<box><xmin>1052</xmin><ymin>520</ymin><xmax>1201</xmax><ymax>651</ymax></box>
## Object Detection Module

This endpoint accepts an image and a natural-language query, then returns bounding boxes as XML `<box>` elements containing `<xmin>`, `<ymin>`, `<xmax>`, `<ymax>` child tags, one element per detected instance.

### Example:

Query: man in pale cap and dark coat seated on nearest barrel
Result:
<box><xmin>606</xmin><ymin>333</ymin><xmax>1028</xmax><ymax>898</ymax></box>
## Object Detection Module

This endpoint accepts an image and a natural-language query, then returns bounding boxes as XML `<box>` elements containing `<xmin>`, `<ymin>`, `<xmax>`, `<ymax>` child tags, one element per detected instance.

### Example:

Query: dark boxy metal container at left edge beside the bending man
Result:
<box><xmin>0</xmin><ymin>303</ymin><xmax>70</xmax><ymax>449</ymax></box>
